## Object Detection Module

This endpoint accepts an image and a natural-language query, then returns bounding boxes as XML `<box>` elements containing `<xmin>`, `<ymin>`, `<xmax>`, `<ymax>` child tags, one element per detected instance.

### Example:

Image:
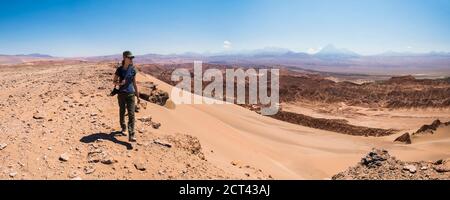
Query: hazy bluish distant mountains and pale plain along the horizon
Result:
<box><xmin>0</xmin><ymin>45</ymin><xmax>450</xmax><ymax>76</ymax></box>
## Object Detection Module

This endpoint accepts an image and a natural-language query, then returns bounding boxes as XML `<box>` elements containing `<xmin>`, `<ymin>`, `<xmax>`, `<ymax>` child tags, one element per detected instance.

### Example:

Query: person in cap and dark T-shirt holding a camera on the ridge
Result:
<box><xmin>113</xmin><ymin>51</ymin><xmax>140</xmax><ymax>142</ymax></box>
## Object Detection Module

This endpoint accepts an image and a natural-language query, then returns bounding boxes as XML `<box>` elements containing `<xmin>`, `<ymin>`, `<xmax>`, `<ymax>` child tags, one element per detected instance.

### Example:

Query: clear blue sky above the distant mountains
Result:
<box><xmin>0</xmin><ymin>0</ymin><xmax>450</xmax><ymax>57</ymax></box>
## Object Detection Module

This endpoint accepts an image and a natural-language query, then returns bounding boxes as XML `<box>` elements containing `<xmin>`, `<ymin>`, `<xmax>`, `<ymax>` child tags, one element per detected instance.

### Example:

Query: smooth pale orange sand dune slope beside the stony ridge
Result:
<box><xmin>140</xmin><ymin>66</ymin><xmax>450</xmax><ymax>179</ymax></box>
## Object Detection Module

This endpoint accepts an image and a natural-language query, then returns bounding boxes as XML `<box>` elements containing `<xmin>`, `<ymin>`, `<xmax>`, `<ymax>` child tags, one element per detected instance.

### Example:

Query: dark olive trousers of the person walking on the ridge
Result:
<box><xmin>117</xmin><ymin>93</ymin><xmax>136</xmax><ymax>136</ymax></box>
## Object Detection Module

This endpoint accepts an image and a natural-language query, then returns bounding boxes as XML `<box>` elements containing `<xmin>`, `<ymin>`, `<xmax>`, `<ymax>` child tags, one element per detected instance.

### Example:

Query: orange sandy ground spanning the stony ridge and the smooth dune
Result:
<box><xmin>0</xmin><ymin>64</ymin><xmax>450</xmax><ymax>179</ymax></box>
